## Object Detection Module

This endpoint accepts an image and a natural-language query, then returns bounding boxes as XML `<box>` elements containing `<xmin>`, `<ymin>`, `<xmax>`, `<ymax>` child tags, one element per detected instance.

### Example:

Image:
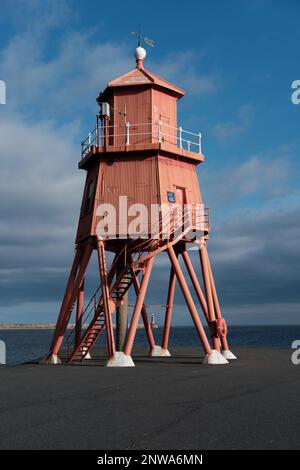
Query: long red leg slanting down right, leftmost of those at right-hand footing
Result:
<box><xmin>167</xmin><ymin>246</ymin><xmax>212</xmax><ymax>354</ymax></box>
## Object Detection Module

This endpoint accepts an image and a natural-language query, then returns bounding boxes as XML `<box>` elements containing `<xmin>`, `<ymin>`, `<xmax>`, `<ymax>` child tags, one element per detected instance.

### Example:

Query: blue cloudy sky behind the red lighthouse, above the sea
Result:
<box><xmin>0</xmin><ymin>0</ymin><xmax>300</xmax><ymax>324</ymax></box>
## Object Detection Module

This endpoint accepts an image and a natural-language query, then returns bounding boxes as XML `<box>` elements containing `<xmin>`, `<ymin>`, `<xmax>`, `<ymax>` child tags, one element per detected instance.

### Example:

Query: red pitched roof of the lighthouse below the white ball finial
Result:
<box><xmin>105</xmin><ymin>68</ymin><xmax>184</xmax><ymax>98</ymax></box>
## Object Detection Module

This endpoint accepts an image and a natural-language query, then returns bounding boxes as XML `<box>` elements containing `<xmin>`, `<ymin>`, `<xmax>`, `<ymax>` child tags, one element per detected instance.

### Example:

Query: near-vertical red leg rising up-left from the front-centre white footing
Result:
<box><xmin>97</xmin><ymin>240</ymin><xmax>116</xmax><ymax>357</ymax></box>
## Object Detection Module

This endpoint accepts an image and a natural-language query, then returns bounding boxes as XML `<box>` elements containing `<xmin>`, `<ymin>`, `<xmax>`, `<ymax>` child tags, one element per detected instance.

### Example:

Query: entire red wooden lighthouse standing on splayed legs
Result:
<box><xmin>46</xmin><ymin>41</ymin><xmax>235</xmax><ymax>366</ymax></box>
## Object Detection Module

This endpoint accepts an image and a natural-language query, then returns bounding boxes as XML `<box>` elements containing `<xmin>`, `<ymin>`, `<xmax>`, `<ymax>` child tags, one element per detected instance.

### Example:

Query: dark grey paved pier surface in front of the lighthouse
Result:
<box><xmin>0</xmin><ymin>348</ymin><xmax>300</xmax><ymax>450</ymax></box>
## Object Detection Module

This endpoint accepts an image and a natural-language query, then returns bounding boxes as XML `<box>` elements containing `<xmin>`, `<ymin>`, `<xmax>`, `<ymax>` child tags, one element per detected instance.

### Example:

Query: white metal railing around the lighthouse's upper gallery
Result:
<box><xmin>81</xmin><ymin>118</ymin><xmax>202</xmax><ymax>158</ymax></box>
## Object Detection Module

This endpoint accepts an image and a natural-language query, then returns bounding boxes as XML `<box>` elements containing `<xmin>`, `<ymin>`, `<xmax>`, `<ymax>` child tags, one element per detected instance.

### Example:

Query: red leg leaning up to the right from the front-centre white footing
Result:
<box><xmin>124</xmin><ymin>256</ymin><xmax>154</xmax><ymax>356</ymax></box>
